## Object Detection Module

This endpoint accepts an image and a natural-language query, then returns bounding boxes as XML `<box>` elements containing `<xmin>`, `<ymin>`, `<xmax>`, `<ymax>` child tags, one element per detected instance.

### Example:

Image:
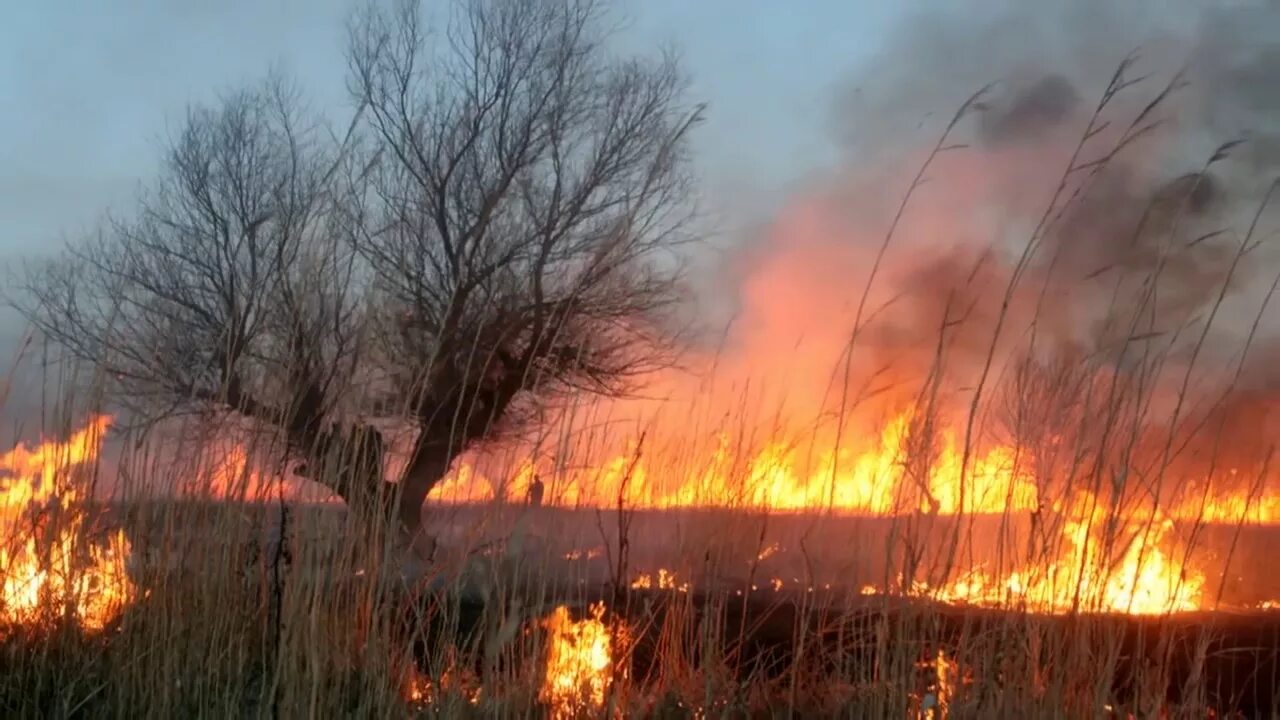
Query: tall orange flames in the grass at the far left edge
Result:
<box><xmin>0</xmin><ymin>416</ymin><xmax>134</xmax><ymax>630</ymax></box>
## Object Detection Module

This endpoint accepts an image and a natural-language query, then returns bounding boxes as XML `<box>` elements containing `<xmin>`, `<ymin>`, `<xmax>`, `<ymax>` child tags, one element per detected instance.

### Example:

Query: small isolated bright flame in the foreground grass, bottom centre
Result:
<box><xmin>539</xmin><ymin>603</ymin><xmax>614</xmax><ymax>717</ymax></box>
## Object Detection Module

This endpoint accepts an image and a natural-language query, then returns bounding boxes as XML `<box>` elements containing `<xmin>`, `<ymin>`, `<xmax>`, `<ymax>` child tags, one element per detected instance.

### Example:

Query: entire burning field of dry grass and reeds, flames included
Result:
<box><xmin>0</xmin><ymin>49</ymin><xmax>1280</xmax><ymax>719</ymax></box>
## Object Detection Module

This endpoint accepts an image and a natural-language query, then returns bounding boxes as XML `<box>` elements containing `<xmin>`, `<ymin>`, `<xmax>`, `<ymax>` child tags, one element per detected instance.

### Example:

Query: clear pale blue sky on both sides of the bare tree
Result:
<box><xmin>0</xmin><ymin>0</ymin><xmax>893</xmax><ymax>261</ymax></box>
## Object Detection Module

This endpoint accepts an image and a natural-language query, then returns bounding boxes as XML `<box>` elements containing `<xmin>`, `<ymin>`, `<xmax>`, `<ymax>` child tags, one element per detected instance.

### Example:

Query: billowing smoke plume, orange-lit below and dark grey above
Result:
<box><xmin>576</xmin><ymin>0</ymin><xmax>1280</xmax><ymax>458</ymax></box>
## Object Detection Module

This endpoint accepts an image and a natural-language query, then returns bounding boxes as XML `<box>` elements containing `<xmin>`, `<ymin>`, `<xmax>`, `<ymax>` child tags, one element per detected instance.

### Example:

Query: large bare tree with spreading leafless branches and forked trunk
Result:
<box><xmin>10</xmin><ymin>0</ymin><xmax>701</xmax><ymax>543</ymax></box>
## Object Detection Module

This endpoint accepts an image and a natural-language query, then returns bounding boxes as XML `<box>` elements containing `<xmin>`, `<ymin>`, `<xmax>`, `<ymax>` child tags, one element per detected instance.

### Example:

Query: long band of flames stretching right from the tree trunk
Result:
<box><xmin>447</xmin><ymin>411</ymin><xmax>1280</xmax><ymax>614</ymax></box>
